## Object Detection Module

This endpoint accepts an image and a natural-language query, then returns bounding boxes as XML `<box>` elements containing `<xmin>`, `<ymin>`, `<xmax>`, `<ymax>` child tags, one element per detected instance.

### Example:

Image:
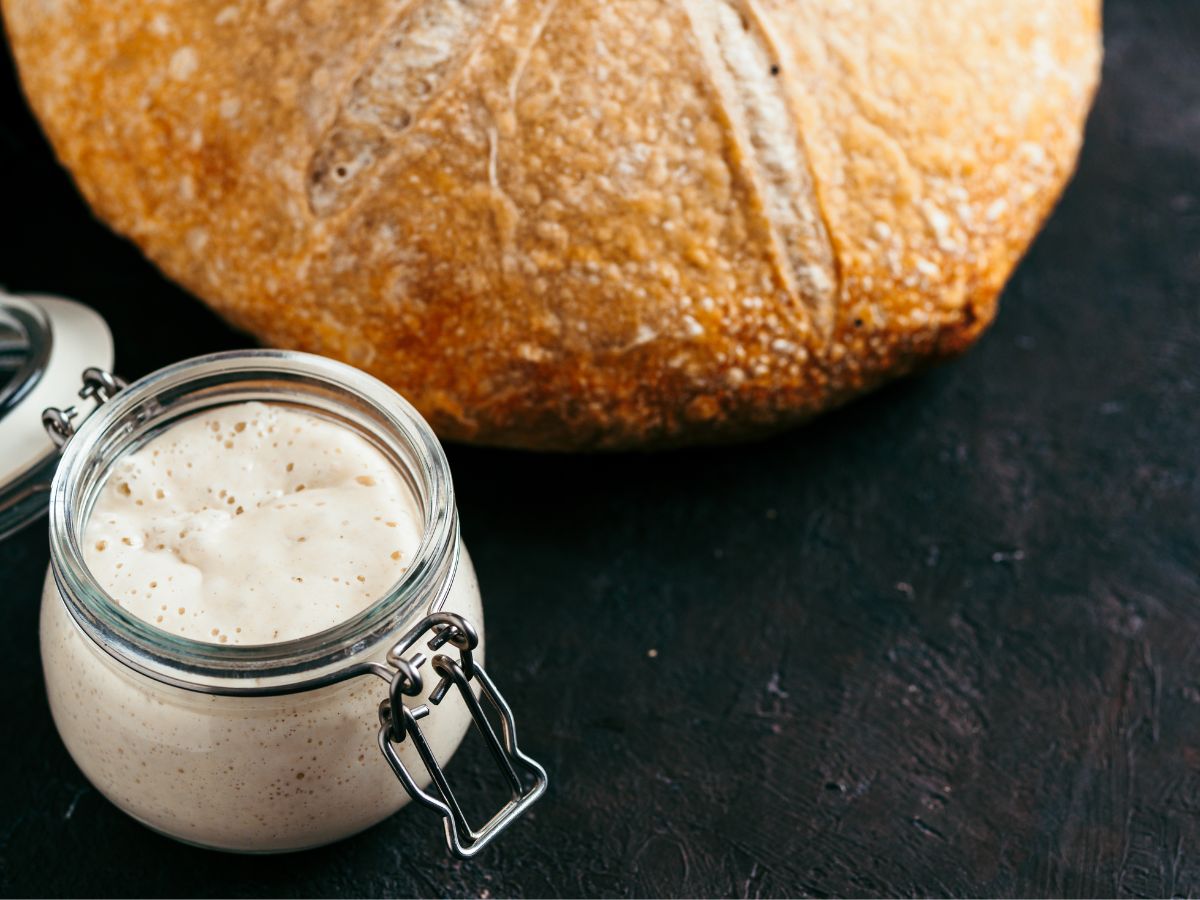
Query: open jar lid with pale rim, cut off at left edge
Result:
<box><xmin>0</xmin><ymin>292</ymin><xmax>113</xmax><ymax>540</ymax></box>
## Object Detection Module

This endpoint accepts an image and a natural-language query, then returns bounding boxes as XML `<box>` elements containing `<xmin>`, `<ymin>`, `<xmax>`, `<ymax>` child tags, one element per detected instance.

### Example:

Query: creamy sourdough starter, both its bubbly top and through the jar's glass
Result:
<box><xmin>42</xmin><ymin>403</ymin><xmax>481</xmax><ymax>851</ymax></box>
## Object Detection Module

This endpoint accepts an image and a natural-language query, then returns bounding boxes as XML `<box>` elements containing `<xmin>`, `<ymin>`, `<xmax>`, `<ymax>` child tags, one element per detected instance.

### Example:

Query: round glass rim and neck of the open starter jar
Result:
<box><xmin>49</xmin><ymin>349</ymin><xmax>458</xmax><ymax>694</ymax></box>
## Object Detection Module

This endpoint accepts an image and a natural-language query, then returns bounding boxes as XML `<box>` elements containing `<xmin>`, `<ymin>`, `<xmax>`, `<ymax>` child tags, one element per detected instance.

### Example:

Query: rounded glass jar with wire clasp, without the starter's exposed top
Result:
<box><xmin>34</xmin><ymin>350</ymin><xmax>546</xmax><ymax>856</ymax></box>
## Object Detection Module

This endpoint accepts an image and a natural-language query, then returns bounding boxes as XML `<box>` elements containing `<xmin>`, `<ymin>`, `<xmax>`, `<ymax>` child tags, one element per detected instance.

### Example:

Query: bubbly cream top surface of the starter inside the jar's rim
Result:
<box><xmin>84</xmin><ymin>403</ymin><xmax>421</xmax><ymax>643</ymax></box>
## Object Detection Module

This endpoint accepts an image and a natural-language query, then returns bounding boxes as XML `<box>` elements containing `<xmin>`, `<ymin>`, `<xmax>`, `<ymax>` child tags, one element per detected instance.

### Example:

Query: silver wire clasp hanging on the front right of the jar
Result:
<box><xmin>379</xmin><ymin>612</ymin><xmax>547</xmax><ymax>858</ymax></box>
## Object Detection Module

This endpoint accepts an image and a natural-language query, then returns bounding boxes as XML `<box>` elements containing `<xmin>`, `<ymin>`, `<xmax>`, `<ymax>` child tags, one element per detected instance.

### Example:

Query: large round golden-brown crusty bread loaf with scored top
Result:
<box><xmin>2</xmin><ymin>0</ymin><xmax>1100</xmax><ymax>449</ymax></box>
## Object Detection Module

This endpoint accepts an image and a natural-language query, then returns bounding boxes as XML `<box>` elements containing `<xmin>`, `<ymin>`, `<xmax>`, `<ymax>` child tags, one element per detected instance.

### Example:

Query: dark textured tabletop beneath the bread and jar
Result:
<box><xmin>0</xmin><ymin>0</ymin><xmax>1200</xmax><ymax>895</ymax></box>
